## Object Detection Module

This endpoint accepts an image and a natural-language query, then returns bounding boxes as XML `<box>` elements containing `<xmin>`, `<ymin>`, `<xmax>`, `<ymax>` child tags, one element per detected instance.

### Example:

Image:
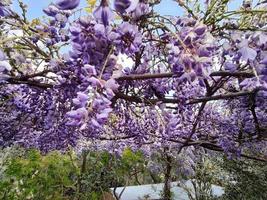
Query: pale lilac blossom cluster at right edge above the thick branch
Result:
<box><xmin>223</xmin><ymin>32</ymin><xmax>267</xmax><ymax>90</ymax></box>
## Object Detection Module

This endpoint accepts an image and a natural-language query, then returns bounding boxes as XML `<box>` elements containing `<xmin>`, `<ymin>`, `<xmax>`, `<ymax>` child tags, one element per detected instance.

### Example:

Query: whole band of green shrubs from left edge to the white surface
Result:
<box><xmin>0</xmin><ymin>148</ymin><xmax>149</xmax><ymax>200</ymax></box>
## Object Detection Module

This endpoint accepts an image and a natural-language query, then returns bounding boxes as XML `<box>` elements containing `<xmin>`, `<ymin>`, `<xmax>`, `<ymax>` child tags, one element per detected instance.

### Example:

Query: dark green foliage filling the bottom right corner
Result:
<box><xmin>180</xmin><ymin>154</ymin><xmax>267</xmax><ymax>200</ymax></box>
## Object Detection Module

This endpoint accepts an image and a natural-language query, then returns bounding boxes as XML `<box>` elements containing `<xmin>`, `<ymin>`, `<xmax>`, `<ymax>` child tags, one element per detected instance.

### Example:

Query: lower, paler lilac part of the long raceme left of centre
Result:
<box><xmin>67</xmin><ymin>65</ymin><xmax>116</xmax><ymax>131</ymax></box>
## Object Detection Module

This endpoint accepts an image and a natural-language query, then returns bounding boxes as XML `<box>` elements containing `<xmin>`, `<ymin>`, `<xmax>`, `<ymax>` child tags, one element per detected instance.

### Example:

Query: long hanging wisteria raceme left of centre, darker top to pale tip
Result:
<box><xmin>61</xmin><ymin>17</ymin><xmax>119</xmax><ymax>134</ymax></box>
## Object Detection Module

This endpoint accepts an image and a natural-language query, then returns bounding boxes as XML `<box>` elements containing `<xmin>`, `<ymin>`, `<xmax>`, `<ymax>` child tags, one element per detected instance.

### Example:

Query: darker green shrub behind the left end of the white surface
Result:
<box><xmin>77</xmin><ymin>149</ymin><xmax>148</xmax><ymax>198</ymax></box>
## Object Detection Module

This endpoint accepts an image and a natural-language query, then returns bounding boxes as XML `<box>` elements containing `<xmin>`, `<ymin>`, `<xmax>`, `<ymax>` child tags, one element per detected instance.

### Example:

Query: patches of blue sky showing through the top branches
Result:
<box><xmin>13</xmin><ymin>0</ymin><xmax>242</xmax><ymax>19</ymax></box>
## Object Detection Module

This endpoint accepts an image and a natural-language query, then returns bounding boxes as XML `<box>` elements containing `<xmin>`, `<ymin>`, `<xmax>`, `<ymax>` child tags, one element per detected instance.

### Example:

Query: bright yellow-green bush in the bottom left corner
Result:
<box><xmin>0</xmin><ymin>150</ymin><xmax>78</xmax><ymax>200</ymax></box>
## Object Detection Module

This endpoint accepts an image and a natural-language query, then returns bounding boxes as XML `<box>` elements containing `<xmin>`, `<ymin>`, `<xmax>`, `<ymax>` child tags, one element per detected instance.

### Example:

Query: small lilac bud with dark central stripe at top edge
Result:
<box><xmin>93</xmin><ymin>0</ymin><xmax>114</xmax><ymax>26</ymax></box>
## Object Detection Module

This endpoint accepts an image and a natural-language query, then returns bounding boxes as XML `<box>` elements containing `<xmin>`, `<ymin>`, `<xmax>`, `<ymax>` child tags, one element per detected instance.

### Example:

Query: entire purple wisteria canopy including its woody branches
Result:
<box><xmin>0</xmin><ymin>0</ymin><xmax>267</xmax><ymax>160</ymax></box>
